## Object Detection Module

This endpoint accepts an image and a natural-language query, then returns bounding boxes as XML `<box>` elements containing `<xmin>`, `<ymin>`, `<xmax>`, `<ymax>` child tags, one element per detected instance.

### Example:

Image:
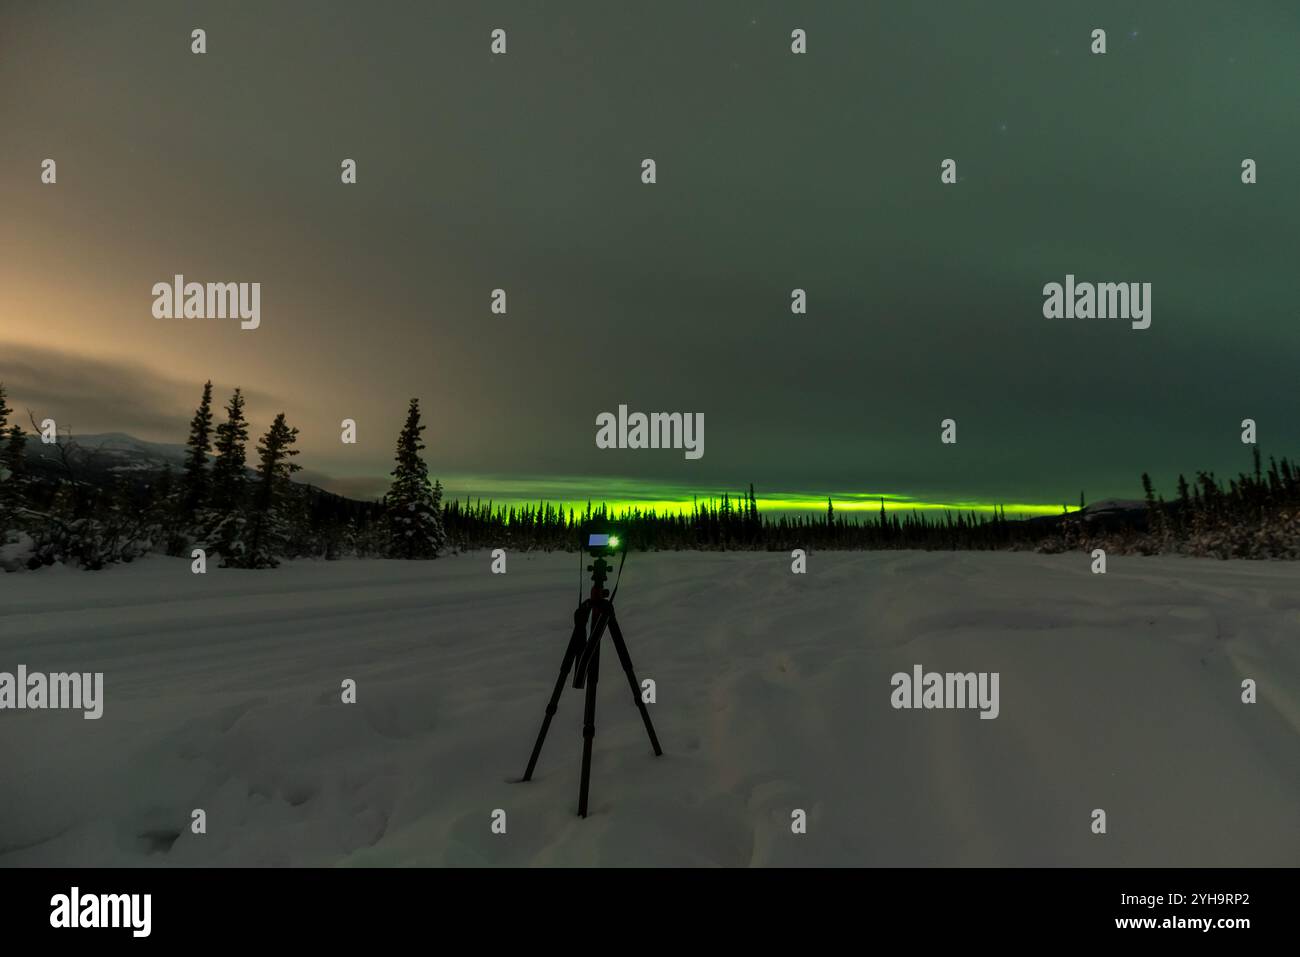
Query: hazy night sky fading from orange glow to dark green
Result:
<box><xmin>0</xmin><ymin>0</ymin><xmax>1300</xmax><ymax>507</ymax></box>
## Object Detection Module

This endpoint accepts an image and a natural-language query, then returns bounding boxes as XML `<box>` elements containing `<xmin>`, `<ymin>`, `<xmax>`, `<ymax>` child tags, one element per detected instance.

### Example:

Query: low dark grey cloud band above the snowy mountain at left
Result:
<box><xmin>0</xmin><ymin>342</ymin><xmax>278</xmax><ymax>442</ymax></box>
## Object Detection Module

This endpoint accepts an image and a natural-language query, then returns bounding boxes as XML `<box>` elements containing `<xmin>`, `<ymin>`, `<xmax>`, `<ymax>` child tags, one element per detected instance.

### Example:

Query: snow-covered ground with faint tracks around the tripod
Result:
<box><xmin>0</xmin><ymin>553</ymin><xmax>1300</xmax><ymax>866</ymax></box>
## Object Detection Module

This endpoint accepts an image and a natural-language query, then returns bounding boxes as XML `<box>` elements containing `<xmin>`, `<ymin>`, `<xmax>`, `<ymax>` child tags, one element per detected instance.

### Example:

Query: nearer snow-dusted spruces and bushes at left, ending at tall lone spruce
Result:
<box><xmin>0</xmin><ymin>382</ymin><xmax>447</xmax><ymax>571</ymax></box>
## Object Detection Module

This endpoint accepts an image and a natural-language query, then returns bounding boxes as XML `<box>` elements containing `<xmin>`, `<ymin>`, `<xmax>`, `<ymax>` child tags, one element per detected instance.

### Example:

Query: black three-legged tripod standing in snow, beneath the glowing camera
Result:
<box><xmin>524</xmin><ymin>553</ymin><xmax>663</xmax><ymax>818</ymax></box>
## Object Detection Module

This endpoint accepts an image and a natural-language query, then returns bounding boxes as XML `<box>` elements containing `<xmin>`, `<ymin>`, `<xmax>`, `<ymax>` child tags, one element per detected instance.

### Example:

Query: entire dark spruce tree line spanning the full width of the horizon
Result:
<box><xmin>0</xmin><ymin>382</ymin><xmax>1300</xmax><ymax>570</ymax></box>
